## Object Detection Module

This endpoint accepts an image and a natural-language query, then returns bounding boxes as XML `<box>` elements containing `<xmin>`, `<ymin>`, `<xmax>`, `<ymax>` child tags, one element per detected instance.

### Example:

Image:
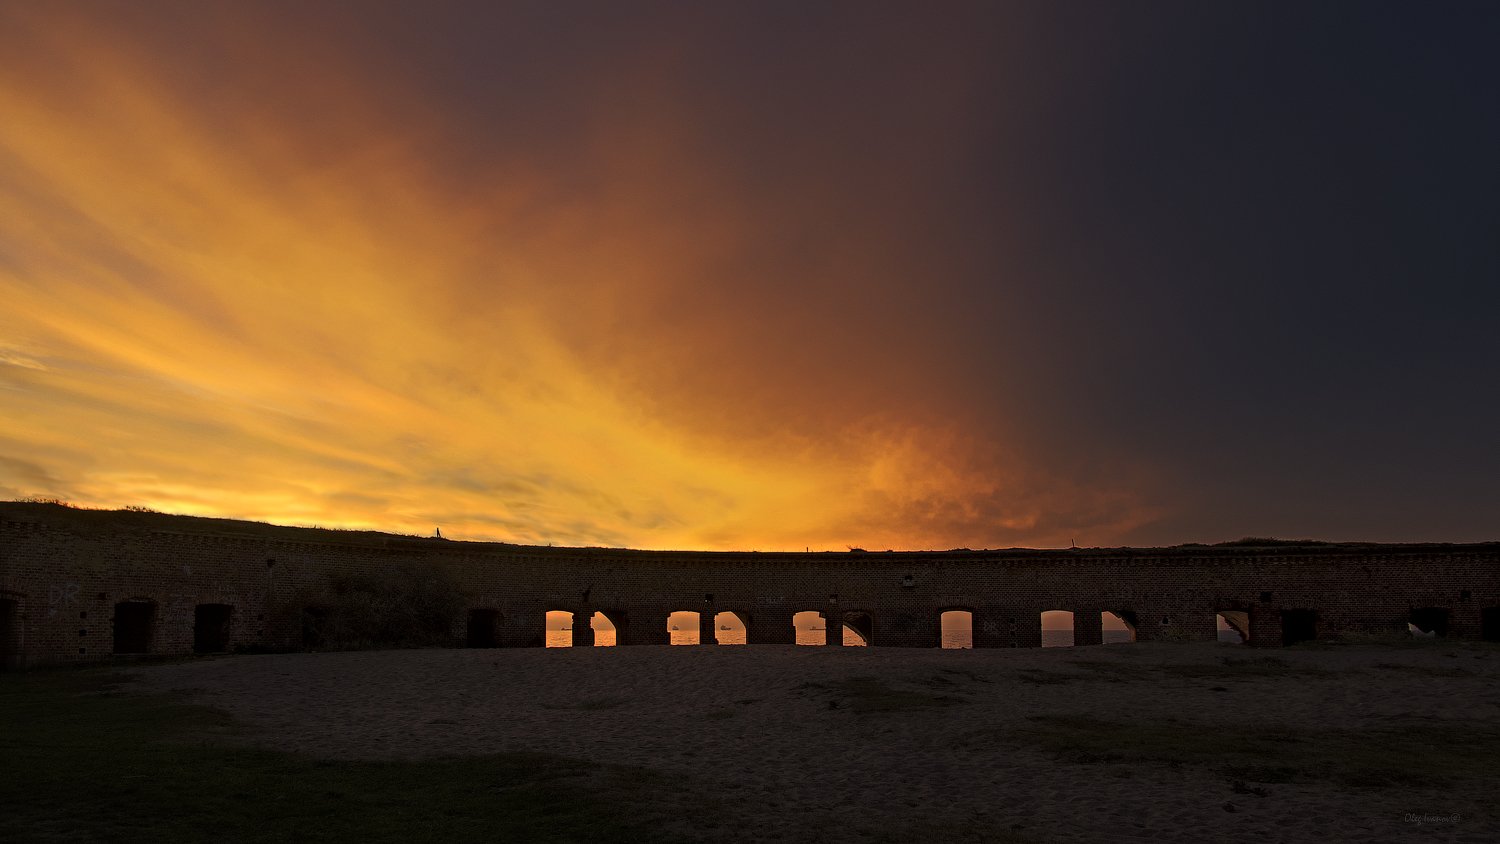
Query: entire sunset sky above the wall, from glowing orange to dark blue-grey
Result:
<box><xmin>0</xmin><ymin>0</ymin><xmax>1500</xmax><ymax>550</ymax></box>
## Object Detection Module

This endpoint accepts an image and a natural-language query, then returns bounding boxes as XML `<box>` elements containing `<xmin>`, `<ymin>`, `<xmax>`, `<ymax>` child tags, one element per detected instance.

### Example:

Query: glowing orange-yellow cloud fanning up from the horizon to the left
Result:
<box><xmin>0</xmin><ymin>3</ymin><xmax>1149</xmax><ymax>549</ymax></box>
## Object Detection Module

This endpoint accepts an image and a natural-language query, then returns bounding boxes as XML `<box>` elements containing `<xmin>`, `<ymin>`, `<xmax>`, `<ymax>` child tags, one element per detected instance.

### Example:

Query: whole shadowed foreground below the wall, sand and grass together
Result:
<box><xmin>0</xmin><ymin>642</ymin><xmax>1500</xmax><ymax>843</ymax></box>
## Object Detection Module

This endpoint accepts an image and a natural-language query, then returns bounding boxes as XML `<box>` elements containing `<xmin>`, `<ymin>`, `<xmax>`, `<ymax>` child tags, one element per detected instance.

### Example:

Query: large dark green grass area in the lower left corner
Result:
<box><xmin>0</xmin><ymin>670</ymin><xmax>681</xmax><ymax>843</ymax></box>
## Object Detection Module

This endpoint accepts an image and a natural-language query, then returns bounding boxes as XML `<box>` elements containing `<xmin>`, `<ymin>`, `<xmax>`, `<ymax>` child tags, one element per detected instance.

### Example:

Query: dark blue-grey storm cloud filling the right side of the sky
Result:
<box><xmin>954</xmin><ymin>4</ymin><xmax>1500</xmax><ymax>538</ymax></box>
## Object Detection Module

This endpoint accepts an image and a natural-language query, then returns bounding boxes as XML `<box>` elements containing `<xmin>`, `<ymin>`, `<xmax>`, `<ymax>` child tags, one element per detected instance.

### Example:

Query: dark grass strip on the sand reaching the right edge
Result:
<box><xmin>989</xmin><ymin>715</ymin><xmax>1500</xmax><ymax>789</ymax></box>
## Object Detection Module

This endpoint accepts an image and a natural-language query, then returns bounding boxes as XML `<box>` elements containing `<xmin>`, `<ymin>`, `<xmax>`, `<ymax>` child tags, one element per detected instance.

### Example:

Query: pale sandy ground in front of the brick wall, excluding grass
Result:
<box><xmin>140</xmin><ymin>643</ymin><xmax>1500</xmax><ymax>843</ymax></box>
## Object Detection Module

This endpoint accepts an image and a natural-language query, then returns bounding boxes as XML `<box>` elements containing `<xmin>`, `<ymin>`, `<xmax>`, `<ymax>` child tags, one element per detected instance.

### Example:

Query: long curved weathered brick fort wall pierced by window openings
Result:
<box><xmin>0</xmin><ymin>504</ymin><xmax>1500</xmax><ymax>667</ymax></box>
